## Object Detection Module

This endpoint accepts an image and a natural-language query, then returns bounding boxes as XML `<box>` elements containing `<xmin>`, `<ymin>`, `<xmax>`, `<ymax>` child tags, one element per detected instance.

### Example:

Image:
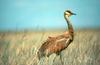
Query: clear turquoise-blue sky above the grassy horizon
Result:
<box><xmin>0</xmin><ymin>0</ymin><xmax>100</xmax><ymax>30</ymax></box>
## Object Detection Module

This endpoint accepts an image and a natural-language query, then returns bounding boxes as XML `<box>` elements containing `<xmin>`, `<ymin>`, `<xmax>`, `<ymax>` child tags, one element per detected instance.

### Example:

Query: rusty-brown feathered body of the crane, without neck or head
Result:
<box><xmin>38</xmin><ymin>33</ymin><xmax>71</xmax><ymax>58</ymax></box>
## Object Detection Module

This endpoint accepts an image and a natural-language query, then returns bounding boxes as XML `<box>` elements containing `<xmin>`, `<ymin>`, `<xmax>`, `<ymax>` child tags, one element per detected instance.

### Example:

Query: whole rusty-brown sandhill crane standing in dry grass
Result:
<box><xmin>38</xmin><ymin>10</ymin><xmax>75</xmax><ymax>64</ymax></box>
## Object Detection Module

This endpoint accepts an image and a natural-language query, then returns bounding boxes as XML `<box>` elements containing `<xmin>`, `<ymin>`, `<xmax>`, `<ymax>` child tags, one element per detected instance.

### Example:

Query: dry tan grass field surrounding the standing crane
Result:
<box><xmin>0</xmin><ymin>30</ymin><xmax>100</xmax><ymax>65</ymax></box>
